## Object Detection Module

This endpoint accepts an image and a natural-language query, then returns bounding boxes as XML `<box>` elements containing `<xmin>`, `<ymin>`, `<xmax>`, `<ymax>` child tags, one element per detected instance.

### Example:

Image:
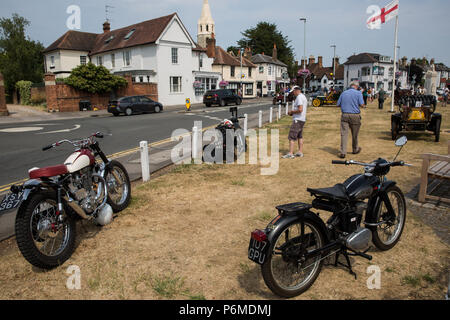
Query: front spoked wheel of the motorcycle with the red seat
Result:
<box><xmin>105</xmin><ymin>161</ymin><xmax>131</xmax><ymax>213</ymax></box>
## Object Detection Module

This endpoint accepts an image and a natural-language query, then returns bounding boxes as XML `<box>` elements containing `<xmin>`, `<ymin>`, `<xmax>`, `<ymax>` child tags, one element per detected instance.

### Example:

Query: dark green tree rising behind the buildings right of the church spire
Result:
<box><xmin>237</xmin><ymin>22</ymin><xmax>297</xmax><ymax>76</ymax></box>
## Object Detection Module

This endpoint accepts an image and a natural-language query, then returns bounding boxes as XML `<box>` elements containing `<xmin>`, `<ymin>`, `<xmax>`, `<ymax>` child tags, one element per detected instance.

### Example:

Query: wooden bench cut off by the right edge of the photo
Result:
<box><xmin>419</xmin><ymin>141</ymin><xmax>450</xmax><ymax>203</ymax></box>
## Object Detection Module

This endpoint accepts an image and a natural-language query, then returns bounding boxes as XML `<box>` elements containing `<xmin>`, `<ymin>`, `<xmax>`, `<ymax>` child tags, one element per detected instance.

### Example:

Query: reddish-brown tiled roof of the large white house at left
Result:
<box><xmin>44</xmin><ymin>13</ymin><xmax>176</xmax><ymax>55</ymax></box>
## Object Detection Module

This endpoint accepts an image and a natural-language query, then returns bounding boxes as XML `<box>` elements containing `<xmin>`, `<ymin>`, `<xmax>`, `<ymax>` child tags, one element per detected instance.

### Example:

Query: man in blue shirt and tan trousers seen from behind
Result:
<box><xmin>337</xmin><ymin>82</ymin><xmax>364</xmax><ymax>159</ymax></box>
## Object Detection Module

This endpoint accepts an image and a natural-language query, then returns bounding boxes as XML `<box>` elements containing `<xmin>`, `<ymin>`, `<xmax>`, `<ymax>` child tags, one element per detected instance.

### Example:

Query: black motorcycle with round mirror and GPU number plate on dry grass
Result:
<box><xmin>248</xmin><ymin>137</ymin><xmax>410</xmax><ymax>298</ymax></box>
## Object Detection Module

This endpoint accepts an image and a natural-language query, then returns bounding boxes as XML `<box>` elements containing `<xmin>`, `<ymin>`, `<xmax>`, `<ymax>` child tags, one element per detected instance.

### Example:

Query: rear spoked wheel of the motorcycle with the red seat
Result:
<box><xmin>15</xmin><ymin>193</ymin><xmax>76</xmax><ymax>269</ymax></box>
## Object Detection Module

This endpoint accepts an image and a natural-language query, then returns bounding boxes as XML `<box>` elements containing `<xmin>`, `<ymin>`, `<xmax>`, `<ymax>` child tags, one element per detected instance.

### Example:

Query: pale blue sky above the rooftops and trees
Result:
<box><xmin>0</xmin><ymin>0</ymin><xmax>450</xmax><ymax>66</ymax></box>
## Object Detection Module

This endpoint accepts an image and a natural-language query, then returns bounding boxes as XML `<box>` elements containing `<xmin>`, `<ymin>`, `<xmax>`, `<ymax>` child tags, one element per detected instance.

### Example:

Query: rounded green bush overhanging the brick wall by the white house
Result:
<box><xmin>64</xmin><ymin>63</ymin><xmax>127</xmax><ymax>93</ymax></box>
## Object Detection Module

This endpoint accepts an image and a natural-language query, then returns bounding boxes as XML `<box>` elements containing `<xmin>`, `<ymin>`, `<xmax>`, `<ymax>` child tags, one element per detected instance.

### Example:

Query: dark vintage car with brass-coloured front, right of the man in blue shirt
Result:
<box><xmin>391</xmin><ymin>95</ymin><xmax>442</xmax><ymax>142</ymax></box>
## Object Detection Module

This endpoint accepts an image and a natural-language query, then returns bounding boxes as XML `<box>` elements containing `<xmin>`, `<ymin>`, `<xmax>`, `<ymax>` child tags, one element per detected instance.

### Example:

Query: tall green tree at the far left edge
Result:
<box><xmin>0</xmin><ymin>13</ymin><xmax>44</xmax><ymax>99</ymax></box>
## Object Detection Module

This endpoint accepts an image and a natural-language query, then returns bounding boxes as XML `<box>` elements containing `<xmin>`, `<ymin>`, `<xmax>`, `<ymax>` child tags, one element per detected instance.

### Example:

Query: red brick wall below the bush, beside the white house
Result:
<box><xmin>44</xmin><ymin>73</ymin><xmax>158</xmax><ymax>112</ymax></box>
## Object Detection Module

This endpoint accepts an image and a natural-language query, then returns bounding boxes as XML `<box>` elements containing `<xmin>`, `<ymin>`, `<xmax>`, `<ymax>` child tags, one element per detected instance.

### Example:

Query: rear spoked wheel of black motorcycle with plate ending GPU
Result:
<box><xmin>262</xmin><ymin>220</ymin><xmax>325</xmax><ymax>298</ymax></box>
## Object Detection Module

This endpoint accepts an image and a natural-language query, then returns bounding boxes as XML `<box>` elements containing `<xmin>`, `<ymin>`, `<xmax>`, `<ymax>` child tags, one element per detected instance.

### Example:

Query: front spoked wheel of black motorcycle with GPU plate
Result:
<box><xmin>372</xmin><ymin>187</ymin><xmax>406</xmax><ymax>251</ymax></box>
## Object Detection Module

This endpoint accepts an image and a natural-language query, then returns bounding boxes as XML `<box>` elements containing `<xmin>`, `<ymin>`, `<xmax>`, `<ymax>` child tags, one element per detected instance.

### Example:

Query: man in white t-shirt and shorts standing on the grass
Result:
<box><xmin>283</xmin><ymin>86</ymin><xmax>308</xmax><ymax>159</ymax></box>
